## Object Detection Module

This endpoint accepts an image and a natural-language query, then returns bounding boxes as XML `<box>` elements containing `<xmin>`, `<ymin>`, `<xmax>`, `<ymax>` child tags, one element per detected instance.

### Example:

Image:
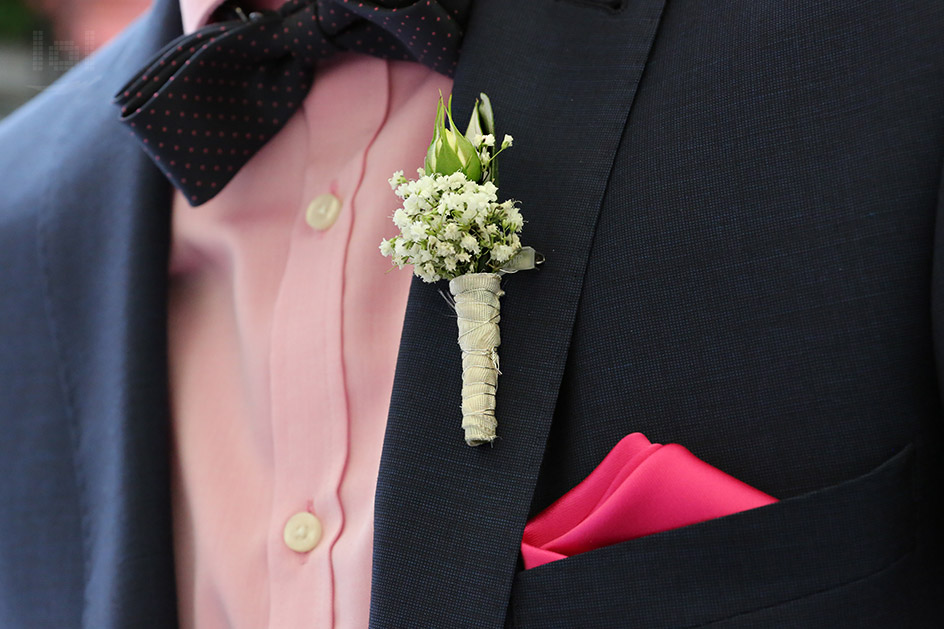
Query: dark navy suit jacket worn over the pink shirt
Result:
<box><xmin>0</xmin><ymin>0</ymin><xmax>944</xmax><ymax>629</ymax></box>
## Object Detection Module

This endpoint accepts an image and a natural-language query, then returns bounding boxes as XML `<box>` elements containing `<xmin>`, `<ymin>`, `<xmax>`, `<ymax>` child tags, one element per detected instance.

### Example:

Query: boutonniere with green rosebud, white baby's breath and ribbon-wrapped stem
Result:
<box><xmin>380</xmin><ymin>94</ymin><xmax>542</xmax><ymax>446</ymax></box>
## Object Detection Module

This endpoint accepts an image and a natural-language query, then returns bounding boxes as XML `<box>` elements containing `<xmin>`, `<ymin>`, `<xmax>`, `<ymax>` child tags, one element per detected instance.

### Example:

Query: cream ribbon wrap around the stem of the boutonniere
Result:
<box><xmin>449</xmin><ymin>273</ymin><xmax>504</xmax><ymax>446</ymax></box>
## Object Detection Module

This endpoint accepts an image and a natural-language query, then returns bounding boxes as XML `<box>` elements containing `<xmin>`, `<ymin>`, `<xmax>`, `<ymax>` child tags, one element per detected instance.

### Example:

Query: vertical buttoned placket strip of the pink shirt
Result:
<box><xmin>267</xmin><ymin>56</ymin><xmax>386</xmax><ymax>627</ymax></box>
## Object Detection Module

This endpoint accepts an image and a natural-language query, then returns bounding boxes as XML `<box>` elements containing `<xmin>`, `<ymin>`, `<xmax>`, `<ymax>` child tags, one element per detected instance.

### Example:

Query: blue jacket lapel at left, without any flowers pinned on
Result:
<box><xmin>31</xmin><ymin>0</ymin><xmax>180</xmax><ymax>629</ymax></box>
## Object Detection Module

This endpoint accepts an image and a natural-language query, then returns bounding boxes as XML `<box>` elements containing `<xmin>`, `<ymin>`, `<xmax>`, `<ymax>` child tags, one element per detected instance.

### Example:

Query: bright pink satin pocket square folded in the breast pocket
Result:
<box><xmin>521</xmin><ymin>432</ymin><xmax>777</xmax><ymax>569</ymax></box>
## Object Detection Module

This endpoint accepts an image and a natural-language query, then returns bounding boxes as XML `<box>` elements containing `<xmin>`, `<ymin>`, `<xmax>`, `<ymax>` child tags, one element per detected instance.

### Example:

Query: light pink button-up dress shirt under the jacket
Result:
<box><xmin>169</xmin><ymin>0</ymin><xmax>451</xmax><ymax>629</ymax></box>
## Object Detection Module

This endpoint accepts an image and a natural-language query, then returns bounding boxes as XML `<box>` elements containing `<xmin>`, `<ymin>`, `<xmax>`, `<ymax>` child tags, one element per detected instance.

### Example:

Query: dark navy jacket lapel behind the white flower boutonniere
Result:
<box><xmin>371</xmin><ymin>0</ymin><xmax>663</xmax><ymax>627</ymax></box>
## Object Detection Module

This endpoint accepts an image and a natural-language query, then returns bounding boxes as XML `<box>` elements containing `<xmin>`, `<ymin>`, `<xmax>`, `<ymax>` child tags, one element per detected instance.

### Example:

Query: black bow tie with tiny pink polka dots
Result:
<box><xmin>115</xmin><ymin>0</ymin><xmax>470</xmax><ymax>206</ymax></box>
